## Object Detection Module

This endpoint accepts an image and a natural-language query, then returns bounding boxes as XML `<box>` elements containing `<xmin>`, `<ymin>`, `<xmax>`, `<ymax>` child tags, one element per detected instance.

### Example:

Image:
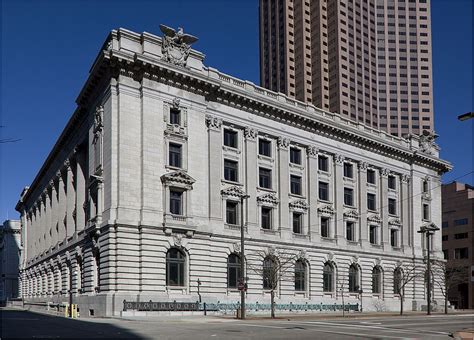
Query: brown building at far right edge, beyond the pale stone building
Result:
<box><xmin>442</xmin><ymin>182</ymin><xmax>474</xmax><ymax>309</ymax></box>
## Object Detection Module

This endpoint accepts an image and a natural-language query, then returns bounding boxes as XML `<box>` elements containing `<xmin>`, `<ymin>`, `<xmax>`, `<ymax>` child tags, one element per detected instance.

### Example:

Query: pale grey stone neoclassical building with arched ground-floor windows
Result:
<box><xmin>16</xmin><ymin>29</ymin><xmax>450</xmax><ymax>315</ymax></box>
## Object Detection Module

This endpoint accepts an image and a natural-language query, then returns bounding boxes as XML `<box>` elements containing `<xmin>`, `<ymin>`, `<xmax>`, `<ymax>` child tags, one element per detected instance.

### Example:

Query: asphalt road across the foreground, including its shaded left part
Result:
<box><xmin>0</xmin><ymin>309</ymin><xmax>474</xmax><ymax>340</ymax></box>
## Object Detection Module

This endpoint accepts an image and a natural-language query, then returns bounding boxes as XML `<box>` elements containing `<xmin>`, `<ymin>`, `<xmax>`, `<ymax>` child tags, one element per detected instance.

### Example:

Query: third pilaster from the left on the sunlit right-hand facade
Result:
<box><xmin>277</xmin><ymin>137</ymin><xmax>292</xmax><ymax>240</ymax></box>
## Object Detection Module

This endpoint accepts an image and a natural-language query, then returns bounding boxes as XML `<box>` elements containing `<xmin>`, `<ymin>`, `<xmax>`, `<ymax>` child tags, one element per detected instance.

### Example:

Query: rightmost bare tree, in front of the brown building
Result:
<box><xmin>431</xmin><ymin>260</ymin><xmax>468</xmax><ymax>314</ymax></box>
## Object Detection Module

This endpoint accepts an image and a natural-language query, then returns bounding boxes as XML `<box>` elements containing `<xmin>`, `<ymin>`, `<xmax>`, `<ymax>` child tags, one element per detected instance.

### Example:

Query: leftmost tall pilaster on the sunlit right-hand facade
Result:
<box><xmin>206</xmin><ymin>115</ymin><xmax>222</xmax><ymax>220</ymax></box>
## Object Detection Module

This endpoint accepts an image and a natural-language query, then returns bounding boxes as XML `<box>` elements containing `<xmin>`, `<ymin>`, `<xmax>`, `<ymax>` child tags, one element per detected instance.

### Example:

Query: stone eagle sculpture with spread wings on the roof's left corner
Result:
<box><xmin>160</xmin><ymin>24</ymin><xmax>198</xmax><ymax>66</ymax></box>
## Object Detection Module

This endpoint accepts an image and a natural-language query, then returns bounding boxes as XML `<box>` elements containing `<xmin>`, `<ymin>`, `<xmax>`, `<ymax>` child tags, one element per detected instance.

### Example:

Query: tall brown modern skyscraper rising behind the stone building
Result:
<box><xmin>260</xmin><ymin>0</ymin><xmax>433</xmax><ymax>136</ymax></box>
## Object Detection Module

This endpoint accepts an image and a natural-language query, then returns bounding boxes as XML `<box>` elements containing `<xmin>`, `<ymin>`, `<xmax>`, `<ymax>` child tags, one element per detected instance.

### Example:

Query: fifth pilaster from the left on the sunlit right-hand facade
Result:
<box><xmin>333</xmin><ymin>154</ymin><xmax>346</xmax><ymax>245</ymax></box>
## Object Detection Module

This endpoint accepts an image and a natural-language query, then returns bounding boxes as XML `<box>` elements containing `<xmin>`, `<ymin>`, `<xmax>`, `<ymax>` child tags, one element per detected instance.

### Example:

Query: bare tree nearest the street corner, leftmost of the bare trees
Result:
<box><xmin>248</xmin><ymin>247</ymin><xmax>301</xmax><ymax>319</ymax></box>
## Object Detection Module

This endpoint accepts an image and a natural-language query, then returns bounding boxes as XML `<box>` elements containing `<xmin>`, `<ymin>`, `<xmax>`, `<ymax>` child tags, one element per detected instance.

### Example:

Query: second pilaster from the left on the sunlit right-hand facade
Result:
<box><xmin>244</xmin><ymin>126</ymin><xmax>259</xmax><ymax>228</ymax></box>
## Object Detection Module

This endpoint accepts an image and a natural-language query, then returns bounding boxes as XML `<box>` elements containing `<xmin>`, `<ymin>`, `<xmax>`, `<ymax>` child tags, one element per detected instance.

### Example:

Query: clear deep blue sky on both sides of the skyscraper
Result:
<box><xmin>0</xmin><ymin>0</ymin><xmax>474</xmax><ymax>221</ymax></box>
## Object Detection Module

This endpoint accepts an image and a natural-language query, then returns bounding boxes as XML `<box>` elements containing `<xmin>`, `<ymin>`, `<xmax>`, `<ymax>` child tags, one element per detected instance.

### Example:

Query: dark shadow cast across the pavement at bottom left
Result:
<box><xmin>0</xmin><ymin>308</ymin><xmax>147</xmax><ymax>339</ymax></box>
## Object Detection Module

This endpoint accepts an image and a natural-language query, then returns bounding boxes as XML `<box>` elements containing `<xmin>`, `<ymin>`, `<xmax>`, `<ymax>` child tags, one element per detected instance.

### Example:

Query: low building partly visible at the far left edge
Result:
<box><xmin>0</xmin><ymin>220</ymin><xmax>22</xmax><ymax>305</ymax></box>
